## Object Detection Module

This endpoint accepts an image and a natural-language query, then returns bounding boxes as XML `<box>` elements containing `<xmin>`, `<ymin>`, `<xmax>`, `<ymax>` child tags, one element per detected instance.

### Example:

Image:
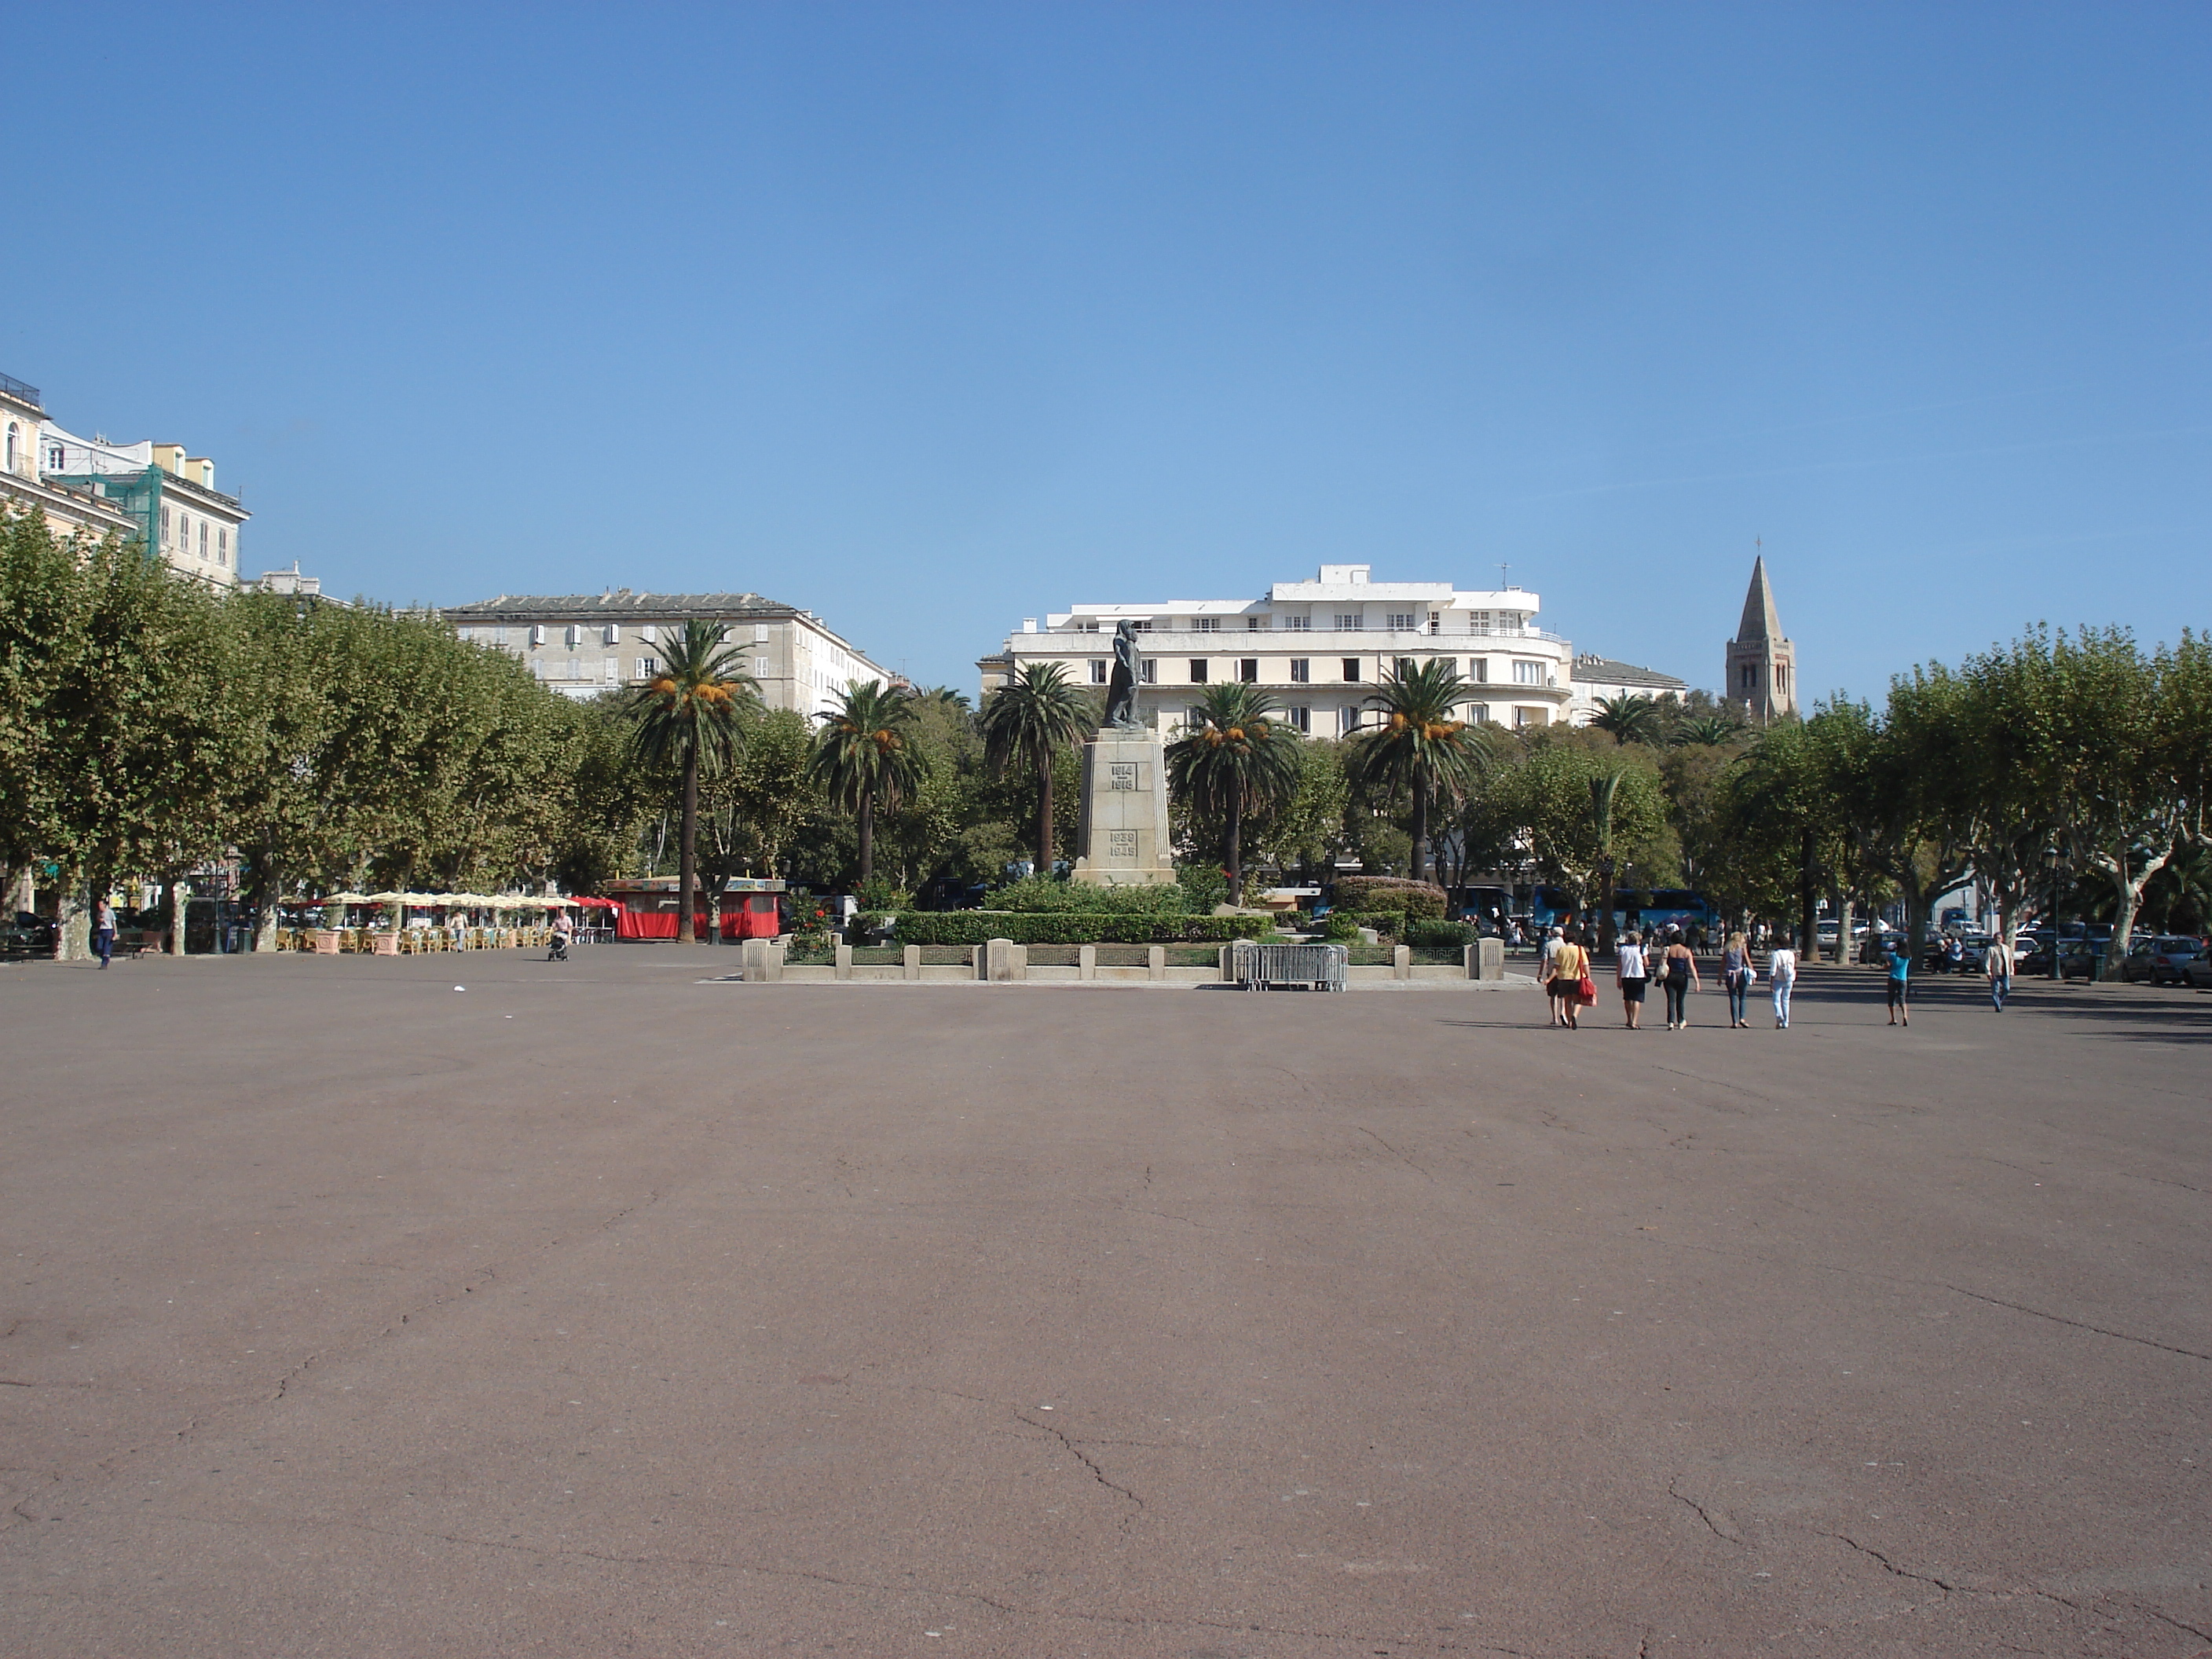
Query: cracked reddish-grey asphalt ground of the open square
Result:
<box><xmin>0</xmin><ymin>947</ymin><xmax>2212</xmax><ymax>1659</ymax></box>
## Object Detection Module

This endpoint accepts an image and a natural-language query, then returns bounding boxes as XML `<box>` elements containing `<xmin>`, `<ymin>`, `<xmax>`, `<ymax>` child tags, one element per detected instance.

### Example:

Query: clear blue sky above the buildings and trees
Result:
<box><xmin>0</xmin><ymin>5</ymin><xmax>2212</xmax><ymax>694</ymax></box>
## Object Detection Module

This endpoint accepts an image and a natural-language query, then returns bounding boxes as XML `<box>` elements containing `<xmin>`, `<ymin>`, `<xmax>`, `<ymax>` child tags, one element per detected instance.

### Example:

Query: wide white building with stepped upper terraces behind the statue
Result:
<box><xmin>976</xmin><ymin>564</ymin><xmax>1575</xmax><ymax>737</ymax></box>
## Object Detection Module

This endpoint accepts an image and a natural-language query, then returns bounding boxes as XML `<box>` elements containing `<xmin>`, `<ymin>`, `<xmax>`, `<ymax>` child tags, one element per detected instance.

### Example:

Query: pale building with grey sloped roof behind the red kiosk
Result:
<box><xmin>440</xmin><ymin>588</ymin><xmax>898</xmax><ymax>716</ymax></box>
